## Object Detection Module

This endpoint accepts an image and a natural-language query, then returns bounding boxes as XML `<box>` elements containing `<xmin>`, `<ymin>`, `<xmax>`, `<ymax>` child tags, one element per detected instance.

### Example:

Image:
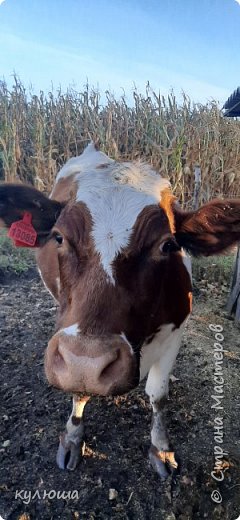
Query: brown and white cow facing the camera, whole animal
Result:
<box><xmin>0</xmin><ymin>144</ymin><xmax>240</xmax><ymax>477</ymax></box>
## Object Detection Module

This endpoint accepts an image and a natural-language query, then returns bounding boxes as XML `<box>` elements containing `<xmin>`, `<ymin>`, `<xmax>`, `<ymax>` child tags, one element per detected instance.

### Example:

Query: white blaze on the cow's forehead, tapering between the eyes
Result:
<box><xmin>77</xmin><ymin>162</ymin><xmax>169</xmax><ymax>283</ymax></box>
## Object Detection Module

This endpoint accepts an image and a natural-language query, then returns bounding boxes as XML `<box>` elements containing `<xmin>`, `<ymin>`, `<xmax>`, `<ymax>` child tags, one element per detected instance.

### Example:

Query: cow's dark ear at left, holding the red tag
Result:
<box><xmin>0</xmin><ymin>184</ymin><xmax>63</xmax><ymax>245</ymax></box>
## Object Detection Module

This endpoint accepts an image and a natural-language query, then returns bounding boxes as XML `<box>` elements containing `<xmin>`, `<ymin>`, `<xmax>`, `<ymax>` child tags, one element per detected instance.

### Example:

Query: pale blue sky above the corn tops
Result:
<box><xmin>0</xmin><ymin>0</ymin><xmax>240</xmax><ymax>103</ymax></box>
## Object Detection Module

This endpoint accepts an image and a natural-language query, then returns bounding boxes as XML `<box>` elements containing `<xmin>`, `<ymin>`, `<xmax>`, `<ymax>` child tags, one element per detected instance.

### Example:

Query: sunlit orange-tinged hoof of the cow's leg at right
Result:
<box><xmin>149</xmin><ymin>446</ymin><xmax>178</xmax><ymax>480</ymax></box>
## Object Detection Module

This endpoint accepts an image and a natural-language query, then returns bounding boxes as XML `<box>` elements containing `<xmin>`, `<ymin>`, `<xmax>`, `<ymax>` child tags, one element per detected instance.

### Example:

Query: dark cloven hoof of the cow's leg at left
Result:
<box><xmin>56</xmin><ymin>434</ymin><xmax>82</xmax><ymax>471</ymax></box>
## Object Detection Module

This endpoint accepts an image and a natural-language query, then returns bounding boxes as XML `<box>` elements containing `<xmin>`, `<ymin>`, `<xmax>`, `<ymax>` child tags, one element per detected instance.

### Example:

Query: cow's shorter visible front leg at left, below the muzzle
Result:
<box><xmin>57</xmin><ymin>395</ymin><xmax>89</xmax><ymax>470</ymax></box>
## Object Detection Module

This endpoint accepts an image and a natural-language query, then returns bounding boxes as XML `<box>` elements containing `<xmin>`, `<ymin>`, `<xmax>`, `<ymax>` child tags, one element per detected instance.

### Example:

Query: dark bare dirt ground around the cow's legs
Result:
<box><xmin>0</xmin><ymin>270</ymin><xmax>240</xmax><ymax>520</ymax></box>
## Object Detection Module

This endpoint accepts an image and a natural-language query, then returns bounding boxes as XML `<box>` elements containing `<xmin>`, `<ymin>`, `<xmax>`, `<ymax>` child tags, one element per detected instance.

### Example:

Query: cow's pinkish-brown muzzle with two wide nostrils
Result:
<box><xmin>45</xmin><ymin>330</ymin><xmax>139</xmax><ymax>395</ymax></box>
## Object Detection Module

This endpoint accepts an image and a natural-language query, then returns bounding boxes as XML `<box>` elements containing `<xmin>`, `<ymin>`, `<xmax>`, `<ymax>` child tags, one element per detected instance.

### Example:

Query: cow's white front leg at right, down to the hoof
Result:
<box><xmin>146</xmin><ymin>334</ymin><xmax>181</xmax><ymax>479</ymax></box>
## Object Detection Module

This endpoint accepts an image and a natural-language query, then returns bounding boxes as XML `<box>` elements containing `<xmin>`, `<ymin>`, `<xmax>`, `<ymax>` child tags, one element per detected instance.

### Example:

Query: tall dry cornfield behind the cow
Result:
<box><xmin>0</xmin><ymin>77</ymin><xmax>240</xmax><ymax>207</ymax></box>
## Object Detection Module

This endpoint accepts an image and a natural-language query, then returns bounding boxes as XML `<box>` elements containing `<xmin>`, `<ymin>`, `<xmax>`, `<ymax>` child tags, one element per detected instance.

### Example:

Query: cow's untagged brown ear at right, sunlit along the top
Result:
<box><xmin>174</xmin><ymin>199</ymin><xmax>240</xmax><ymax>256</ymax></box>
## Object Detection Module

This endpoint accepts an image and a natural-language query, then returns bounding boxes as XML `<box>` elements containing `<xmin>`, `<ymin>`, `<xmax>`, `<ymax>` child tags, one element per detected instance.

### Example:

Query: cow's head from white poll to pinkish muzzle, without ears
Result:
<box><xmin>38</xmin><ymin>156</ymin><xmax>188</xmax><ymax>394</ymax></box>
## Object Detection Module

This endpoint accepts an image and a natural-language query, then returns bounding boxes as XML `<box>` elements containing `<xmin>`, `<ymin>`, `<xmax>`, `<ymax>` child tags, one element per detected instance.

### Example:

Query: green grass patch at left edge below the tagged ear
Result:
<box><xmin>0</xmin><ymin>230</ymin><xmax>34</xmax><ymax>274</ymax></box>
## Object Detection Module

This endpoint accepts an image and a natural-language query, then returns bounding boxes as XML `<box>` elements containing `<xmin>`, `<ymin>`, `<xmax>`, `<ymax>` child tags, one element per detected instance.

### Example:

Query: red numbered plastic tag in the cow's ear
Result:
<box><xmin>8</xmin><ymin>213</ymin><xmax>37</xmax><ymax>247</ymax></box>
